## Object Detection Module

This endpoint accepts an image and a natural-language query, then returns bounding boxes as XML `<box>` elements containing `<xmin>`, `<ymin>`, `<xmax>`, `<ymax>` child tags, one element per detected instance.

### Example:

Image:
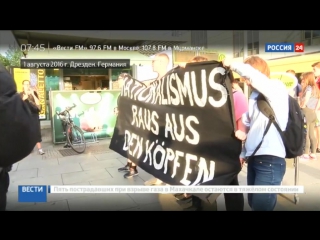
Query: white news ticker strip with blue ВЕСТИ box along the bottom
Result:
<box><xmin>18</xmin><ymin>185</ymin><xmax>304</xmax><ymax>202</ymax></box>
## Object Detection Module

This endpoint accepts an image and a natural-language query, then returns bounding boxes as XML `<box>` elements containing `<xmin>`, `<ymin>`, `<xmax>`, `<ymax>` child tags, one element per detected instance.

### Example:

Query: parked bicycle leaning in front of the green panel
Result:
<box><xmin>56</xmin><ymin>104</ymin><xmax>86</xmax><ymax>153</ymax></box>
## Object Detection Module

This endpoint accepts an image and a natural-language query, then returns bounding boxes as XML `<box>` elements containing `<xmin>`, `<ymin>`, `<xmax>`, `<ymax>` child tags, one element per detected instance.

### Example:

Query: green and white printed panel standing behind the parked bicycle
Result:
<box><xmin>51</xmin><ymin>90</ymin><xmax>120</xmax><ymax>143</ymax></box>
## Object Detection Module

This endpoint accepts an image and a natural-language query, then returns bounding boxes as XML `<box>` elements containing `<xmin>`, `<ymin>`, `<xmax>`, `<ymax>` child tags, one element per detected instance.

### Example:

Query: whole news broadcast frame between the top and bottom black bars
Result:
<box><xmin>0</xmin><ymin>30</ymin><xmax>320</xmax><ymax>211</ymax></box>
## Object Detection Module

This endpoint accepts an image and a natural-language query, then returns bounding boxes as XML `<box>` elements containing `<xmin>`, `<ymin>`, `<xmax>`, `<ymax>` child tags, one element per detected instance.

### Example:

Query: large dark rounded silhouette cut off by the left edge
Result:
<box><xmin>0</xmin><ymin>64</ymin><xmax>39</xmax><ymax>167</ymax></box>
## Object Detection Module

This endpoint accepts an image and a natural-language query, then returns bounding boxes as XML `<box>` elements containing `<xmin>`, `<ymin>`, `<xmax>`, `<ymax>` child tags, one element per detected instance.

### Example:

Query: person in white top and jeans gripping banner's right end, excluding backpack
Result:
<box><xmin>224</xmin><ymin>56</ymin><xmax>289</xmax><ymax>211</ymax></box>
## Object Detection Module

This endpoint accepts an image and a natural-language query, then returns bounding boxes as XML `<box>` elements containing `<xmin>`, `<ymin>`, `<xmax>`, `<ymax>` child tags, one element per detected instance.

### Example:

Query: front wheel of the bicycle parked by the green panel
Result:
<box><xmin>67</xmin><ymin>126</ymin><xmax>86</xmax><ymax>153</ymax></box>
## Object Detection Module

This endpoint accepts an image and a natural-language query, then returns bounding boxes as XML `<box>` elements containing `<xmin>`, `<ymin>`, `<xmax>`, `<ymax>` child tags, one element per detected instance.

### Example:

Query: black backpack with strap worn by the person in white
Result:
<box><xmin>251</xmin><ymin>94</ymin><xmax>307</xmax><ymax>158</ymax></box>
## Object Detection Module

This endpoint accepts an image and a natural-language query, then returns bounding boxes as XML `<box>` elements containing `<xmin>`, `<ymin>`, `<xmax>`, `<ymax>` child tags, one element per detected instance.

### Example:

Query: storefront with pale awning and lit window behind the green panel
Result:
<box><xmin>24</xmin><ymin>50</ymin><xmax>152</xmax><ymax>120</ymax></box>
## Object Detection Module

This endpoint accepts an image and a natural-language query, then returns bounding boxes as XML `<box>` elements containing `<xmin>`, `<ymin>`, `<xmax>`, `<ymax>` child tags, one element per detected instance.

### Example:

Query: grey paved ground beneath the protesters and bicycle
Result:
<box><xmin>7</xmin><ymin>129</ymin><xmax>320</xmax><ymax>211</ymax></box>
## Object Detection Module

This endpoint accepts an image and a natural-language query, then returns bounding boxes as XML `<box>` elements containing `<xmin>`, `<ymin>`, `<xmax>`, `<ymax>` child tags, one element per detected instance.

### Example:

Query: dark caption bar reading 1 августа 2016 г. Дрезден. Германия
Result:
<box><xmin>20</xmin><ymin>59</ymin><xmax>130</xmax><ymax>69</ymax></box>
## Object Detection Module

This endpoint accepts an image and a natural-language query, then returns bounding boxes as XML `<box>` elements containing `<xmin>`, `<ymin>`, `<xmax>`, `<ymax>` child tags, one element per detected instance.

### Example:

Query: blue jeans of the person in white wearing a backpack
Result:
<box><xmin>247</xmin><ymin>155</ymin><xmax>286</xmax><ymax>211</ymax></box>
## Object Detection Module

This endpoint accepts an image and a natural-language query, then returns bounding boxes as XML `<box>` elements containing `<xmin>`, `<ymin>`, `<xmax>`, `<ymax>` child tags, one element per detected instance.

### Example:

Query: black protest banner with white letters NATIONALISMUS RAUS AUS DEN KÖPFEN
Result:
<box><xmin>110</xmin><ymin>61</ymin><xmax>241</xmax><ymax>185</ymax></box>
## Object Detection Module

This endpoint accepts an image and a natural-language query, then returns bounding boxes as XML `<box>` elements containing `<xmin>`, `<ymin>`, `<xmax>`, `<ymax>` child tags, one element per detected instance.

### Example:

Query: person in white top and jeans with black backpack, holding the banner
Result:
<box><xmin>224</xmin><ymin>56</ymin><xmax>303</xmax><ymax>211</ymax></box>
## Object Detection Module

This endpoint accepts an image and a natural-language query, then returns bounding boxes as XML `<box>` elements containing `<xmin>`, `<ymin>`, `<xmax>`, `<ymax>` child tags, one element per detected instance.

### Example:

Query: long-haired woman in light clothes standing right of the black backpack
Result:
<box><xmin>300</xmin><ymin>72</ymin><xmax>320</xmax><ymax>159</ymax></box>
